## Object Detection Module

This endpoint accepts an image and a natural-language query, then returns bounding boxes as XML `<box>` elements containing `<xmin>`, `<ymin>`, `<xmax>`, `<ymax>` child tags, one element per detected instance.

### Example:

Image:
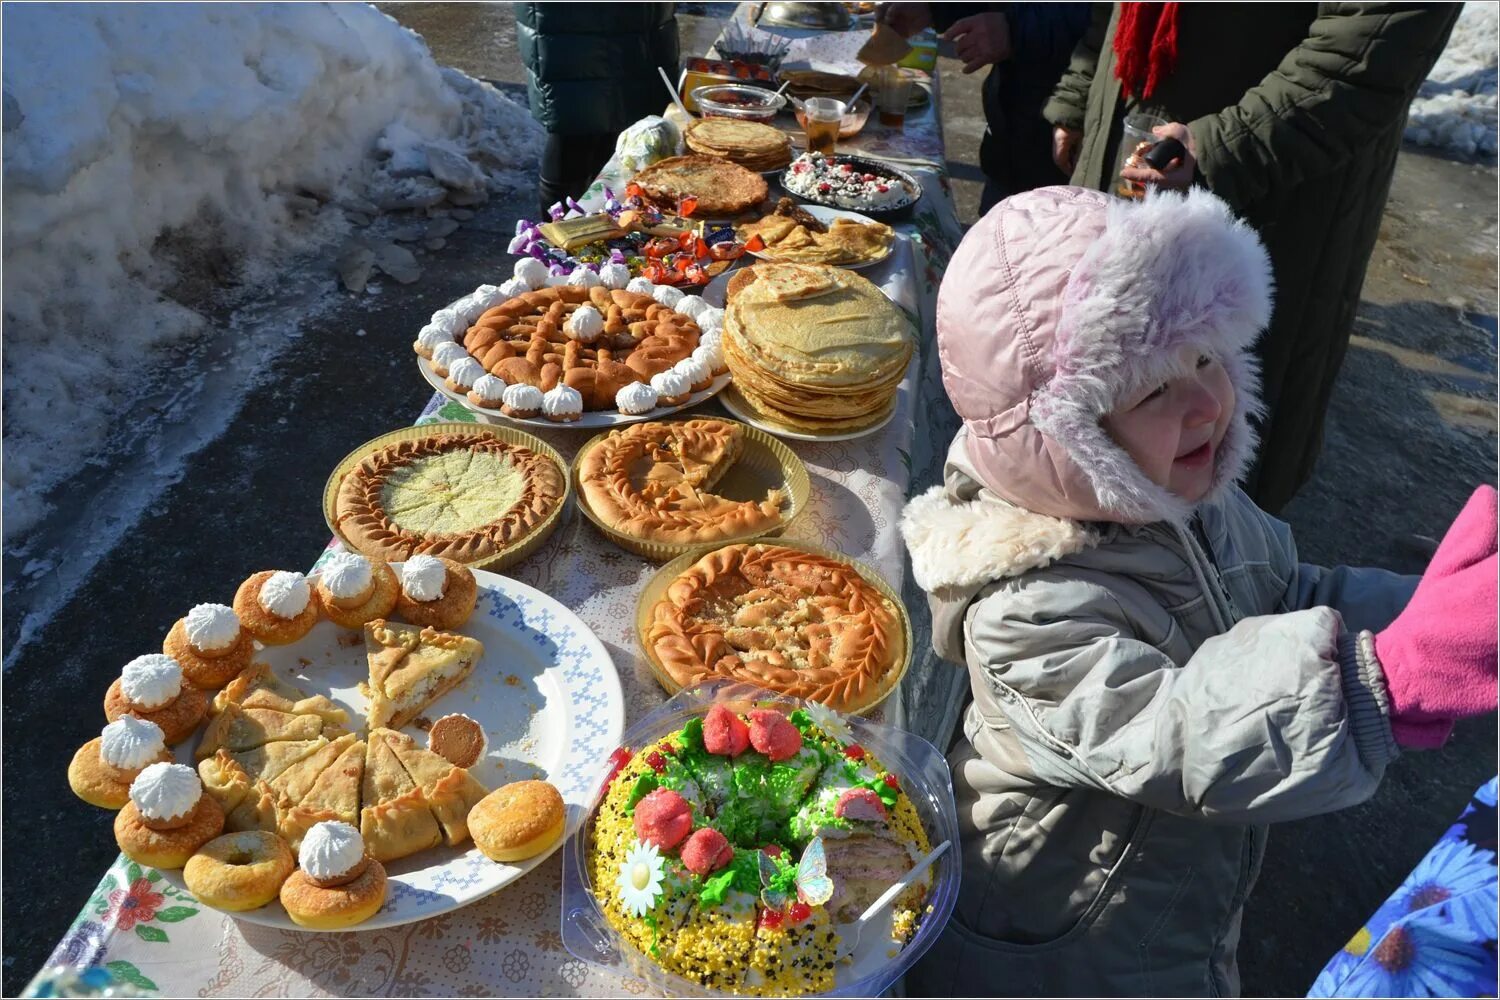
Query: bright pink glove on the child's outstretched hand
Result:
<box><xmin>1376</xmin><ymin>486</ymin><xmax>1500</xmax><ymax>750</ymax></box>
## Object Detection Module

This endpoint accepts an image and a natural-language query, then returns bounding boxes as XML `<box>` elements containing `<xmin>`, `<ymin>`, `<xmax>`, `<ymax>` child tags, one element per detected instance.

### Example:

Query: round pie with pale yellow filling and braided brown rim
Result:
<box><xmin>335</xmin><ymin>433</ymin><xmax>564</xmax><ymax>562</ymax></box>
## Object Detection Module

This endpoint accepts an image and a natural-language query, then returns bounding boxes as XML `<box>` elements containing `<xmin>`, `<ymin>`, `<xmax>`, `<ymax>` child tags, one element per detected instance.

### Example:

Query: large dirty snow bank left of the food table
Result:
<box><xmin>3</xmin><ymin>3</ymin><xmax>542</xmax><ymax>540</ymax></box>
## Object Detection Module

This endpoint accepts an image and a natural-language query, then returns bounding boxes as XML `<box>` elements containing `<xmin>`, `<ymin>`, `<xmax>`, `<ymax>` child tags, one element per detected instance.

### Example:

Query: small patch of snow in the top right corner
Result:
<box><xmin>1406</xmin><ymin>3</ymin><xmax>1500</xmax><ymax>160</ymax></box>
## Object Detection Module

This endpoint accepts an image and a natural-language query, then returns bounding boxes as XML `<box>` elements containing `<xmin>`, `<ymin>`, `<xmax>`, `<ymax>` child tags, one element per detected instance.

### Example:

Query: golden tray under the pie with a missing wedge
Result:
<box><xmin>569</xmin><ymin>417</ymin><xmax>813</xmax><ymax>562</ymax></box>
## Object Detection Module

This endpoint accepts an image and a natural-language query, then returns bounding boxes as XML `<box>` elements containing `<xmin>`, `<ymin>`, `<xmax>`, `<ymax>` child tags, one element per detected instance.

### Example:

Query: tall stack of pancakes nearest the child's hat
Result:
<box><xmin>723</xmin><ymin>264</ymin><xmax>915</xmax><ymax>433</ymax></box>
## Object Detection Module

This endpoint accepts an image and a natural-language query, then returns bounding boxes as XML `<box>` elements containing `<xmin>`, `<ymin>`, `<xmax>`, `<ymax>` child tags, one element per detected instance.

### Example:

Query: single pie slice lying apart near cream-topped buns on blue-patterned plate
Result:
<box><xmin>365</xmin><ymin>618</ymin><xmax>485</xmax><ymax>731</ymax></box>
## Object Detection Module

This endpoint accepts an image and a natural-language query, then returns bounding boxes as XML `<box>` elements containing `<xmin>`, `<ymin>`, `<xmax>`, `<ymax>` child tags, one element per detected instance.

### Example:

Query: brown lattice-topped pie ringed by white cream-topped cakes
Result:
<box><xmin>464</xmin><ymin>285</ymin><xmax>701</xmax><ymax>409</ymax></box>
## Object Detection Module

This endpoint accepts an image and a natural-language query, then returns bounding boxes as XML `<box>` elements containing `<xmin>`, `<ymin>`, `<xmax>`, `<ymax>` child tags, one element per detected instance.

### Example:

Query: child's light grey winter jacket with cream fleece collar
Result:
<box><xmin>902</xmin><ymin>432</ymin><xmax>1416</xmax><ymax>996</ymax></box>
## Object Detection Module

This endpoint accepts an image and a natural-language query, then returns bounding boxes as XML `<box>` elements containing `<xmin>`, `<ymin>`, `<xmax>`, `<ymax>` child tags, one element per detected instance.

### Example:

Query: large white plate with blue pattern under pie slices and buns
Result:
<box><xmin>162</xmin><ymin>564</ymin><xmax>626</xmax><ymax>933</ymax></box>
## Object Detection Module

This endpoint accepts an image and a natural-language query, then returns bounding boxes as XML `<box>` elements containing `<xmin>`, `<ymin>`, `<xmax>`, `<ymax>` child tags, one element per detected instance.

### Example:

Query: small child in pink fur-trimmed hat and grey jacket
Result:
<box><xmin>902</xmin><ymin>187</ymin><xmax>1497</xmax><ymax>996</ymax></box>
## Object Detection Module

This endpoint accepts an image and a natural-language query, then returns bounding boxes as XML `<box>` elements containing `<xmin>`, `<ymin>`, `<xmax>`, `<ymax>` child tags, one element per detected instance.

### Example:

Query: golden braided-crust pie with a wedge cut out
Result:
<box><xmin>578</xmin><ymin>420</ymin><xmax>783</xmax><ymax>544</ymax></box>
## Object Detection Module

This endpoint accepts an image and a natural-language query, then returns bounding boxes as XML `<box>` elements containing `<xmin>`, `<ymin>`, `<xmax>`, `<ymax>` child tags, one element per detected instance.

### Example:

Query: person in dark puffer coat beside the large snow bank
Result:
<box><xmin>512</xmin><ymin>3</ymin><xmax>678</xmax><ymax>210</ymax></box>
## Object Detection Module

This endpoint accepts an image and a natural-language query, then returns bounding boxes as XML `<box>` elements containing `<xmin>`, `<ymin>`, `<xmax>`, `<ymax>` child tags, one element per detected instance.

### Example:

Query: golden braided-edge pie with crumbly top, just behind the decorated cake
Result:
<box><xmin>647</xmin><ymin>544</ymin><xmax>906</xmax><ymax>712</ymax></box>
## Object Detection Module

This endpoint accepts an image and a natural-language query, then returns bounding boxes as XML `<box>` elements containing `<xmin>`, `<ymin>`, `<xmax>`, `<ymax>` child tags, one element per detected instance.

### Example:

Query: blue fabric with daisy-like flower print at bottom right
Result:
<box><xmin>1308</xmin><ymin>778</ymin><xmax>1497</xmax><ymax>997</ymax></box>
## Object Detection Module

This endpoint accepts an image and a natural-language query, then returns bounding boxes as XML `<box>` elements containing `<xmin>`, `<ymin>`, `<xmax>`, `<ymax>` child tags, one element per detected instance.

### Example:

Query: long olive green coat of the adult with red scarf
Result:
<box><xmin>1043</xmin><ymin>3</ymin><xmax>1461</xmax><ymax>511</ymax></box>
